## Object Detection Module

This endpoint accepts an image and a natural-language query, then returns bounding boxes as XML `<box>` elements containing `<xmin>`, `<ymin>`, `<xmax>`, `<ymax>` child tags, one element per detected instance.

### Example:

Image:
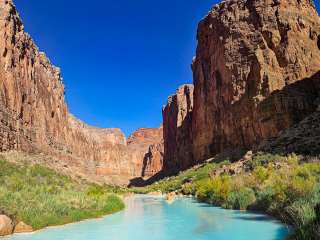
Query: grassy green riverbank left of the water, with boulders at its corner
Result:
<box><xmin>0</xmin><ymin>158</ymin><xmax>125</xmax><ymax>235</ymax></box>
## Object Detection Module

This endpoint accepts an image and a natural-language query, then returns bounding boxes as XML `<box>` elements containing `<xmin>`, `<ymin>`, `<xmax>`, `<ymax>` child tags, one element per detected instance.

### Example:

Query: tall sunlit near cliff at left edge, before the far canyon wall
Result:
<box><xmin>0</xmin><ymin>0</ymin><xmax>68</xmax><ymax>151</ymax></box>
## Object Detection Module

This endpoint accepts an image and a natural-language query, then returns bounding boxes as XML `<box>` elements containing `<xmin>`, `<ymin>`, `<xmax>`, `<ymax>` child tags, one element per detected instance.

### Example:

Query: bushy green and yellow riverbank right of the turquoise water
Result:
<box><xmin>133</xmin><ymin>153</ymin><xmax>320</xmax><ymax>240</ymax></box>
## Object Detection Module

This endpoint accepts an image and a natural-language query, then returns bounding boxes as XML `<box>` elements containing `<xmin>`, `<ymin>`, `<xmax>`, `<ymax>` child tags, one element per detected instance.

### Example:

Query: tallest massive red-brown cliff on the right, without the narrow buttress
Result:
<box><xmin>191</xmin><ymin>0</ymin><xmax>320</xmax><ymax>160</ymax></box>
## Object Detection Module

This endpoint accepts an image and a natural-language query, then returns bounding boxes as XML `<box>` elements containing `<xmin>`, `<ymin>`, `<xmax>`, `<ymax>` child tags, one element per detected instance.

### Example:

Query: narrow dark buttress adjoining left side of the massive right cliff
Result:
<box><xmin>162</xmin><ymin>84</ymin><xmax>194</xmax><ymax>173</ymax></box>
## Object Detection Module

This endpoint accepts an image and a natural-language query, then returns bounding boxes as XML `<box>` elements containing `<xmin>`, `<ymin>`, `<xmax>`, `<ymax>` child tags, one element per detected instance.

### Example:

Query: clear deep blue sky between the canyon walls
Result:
<box><xmin>15</xmin><ymin>0</ymin><xmax>320</xmax><ymax>135</ymax></box>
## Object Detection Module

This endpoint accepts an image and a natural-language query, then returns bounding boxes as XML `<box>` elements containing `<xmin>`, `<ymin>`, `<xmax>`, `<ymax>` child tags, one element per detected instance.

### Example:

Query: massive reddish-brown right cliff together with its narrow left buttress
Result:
<box><xmin>163</xmin><ymin>0</ymin><xmax>320</xmax><ymax>173</ymax></box>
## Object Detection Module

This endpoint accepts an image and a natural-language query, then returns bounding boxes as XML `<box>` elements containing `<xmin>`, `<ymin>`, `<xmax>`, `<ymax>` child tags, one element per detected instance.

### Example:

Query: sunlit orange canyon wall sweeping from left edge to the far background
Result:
<box><xmin>0</xmin><ymin>0</ymin><xmax>162</xmax><ymax>184</ymax></box>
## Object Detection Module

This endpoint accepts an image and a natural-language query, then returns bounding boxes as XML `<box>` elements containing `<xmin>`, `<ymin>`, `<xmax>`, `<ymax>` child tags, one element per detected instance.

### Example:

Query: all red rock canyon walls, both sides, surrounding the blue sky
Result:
<box><xmin>0</xmin><ymin>0</ymin><xmax>320</xmax><ymax>185</ymax></box>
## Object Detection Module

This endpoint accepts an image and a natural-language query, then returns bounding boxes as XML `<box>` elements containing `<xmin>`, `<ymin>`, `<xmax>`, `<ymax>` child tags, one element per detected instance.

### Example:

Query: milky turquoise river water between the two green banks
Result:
<box><xmin>4</xmin><ymin>195</ymin><xmax>289</xmax><ymax>240</ymax></box>
